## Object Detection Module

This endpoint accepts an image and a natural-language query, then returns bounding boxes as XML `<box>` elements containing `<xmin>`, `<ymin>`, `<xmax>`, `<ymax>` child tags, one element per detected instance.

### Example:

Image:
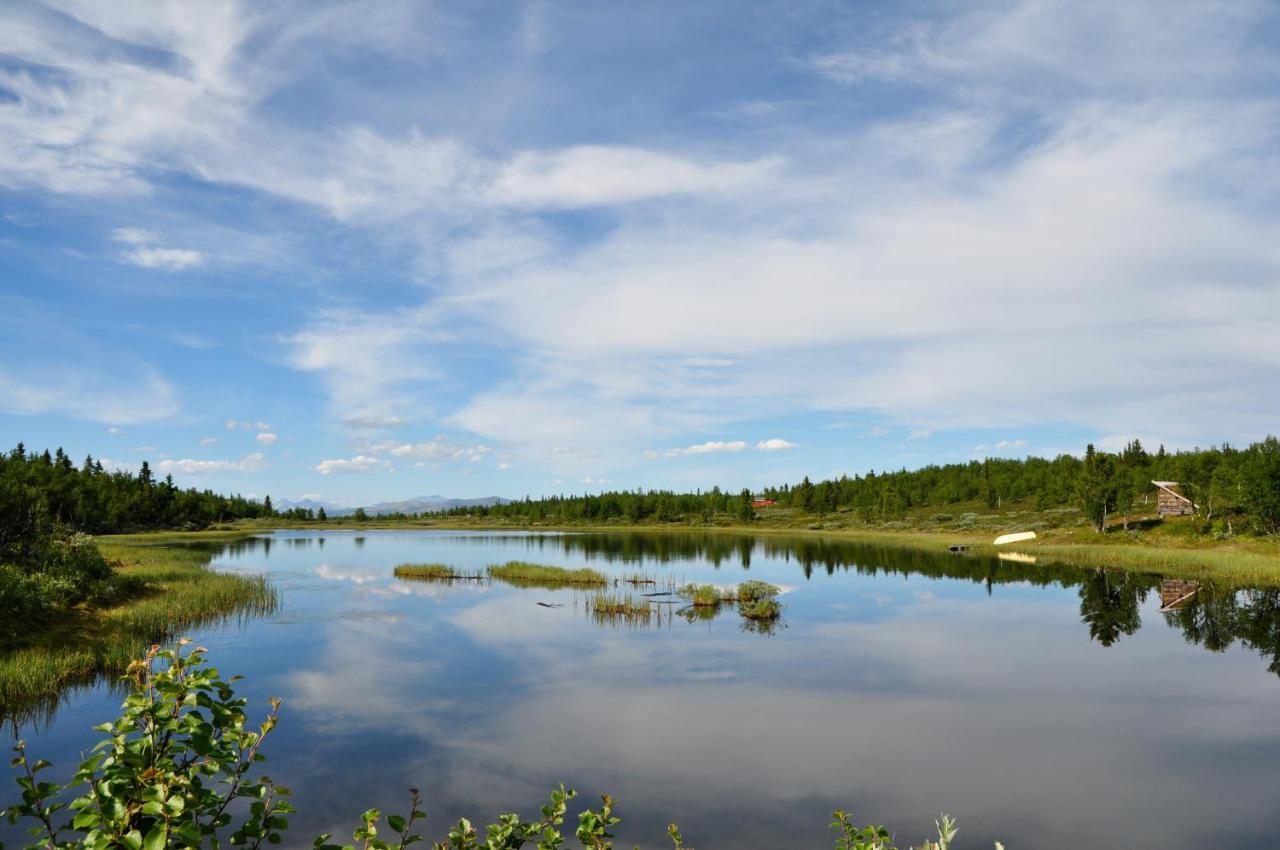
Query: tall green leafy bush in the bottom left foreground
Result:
<box><xmin>8</xmin><ymin>641</ymin><xmax>293</xmax><ymax>850</ymax></box>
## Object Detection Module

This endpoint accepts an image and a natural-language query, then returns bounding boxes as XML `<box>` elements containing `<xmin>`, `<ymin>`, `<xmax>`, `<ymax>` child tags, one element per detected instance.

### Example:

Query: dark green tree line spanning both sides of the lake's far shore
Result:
<box><xmin>0</xmin><ymin>437</ymin><xmax>1280</xmax><ymax>535</ymax></box>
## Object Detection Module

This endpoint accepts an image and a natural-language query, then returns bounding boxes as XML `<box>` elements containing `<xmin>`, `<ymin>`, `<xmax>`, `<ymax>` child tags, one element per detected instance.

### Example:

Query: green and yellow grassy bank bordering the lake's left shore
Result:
<box><xmin>0</xmin><ymin>533</ymin><xmax>276</xmax><ymax>714</ymax></box>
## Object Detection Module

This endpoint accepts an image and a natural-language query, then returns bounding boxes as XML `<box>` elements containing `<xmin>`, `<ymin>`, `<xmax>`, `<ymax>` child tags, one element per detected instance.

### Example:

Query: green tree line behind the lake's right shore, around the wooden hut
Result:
<box><xmin>447</xmin><ymin>437</ymin><xmax>1280</xmax><ymax>534</ymax></box>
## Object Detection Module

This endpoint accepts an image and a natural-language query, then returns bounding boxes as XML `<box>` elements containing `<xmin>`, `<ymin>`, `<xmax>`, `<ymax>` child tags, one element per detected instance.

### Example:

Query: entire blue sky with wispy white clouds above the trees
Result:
<box><xmin>0</xmin><ymin>0</ymin><xmax>1280</xmax><ymax>504</ymax></box>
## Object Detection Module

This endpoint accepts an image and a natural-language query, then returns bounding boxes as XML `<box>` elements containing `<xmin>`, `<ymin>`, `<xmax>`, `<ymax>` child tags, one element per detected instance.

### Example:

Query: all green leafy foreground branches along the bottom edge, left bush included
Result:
<box><xmin>0</xmin><ymin>640</ymin><xmax>1000</xmax><ymax>850</ymax></box>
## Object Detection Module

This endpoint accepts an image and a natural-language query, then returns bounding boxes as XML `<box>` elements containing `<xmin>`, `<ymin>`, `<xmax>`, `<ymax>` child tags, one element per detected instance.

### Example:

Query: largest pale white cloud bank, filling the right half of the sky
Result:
<box><xmin>432</xmin><ymin>3</ymin><xmax>1280</xmax><ymax>456</ymax></box>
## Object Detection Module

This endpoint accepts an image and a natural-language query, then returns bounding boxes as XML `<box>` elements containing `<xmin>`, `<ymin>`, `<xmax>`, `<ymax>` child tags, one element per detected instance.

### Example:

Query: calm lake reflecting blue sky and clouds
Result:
<box><xmin>0</xmin><ymin>531</ymin><xmax>1280</xmax><ymax>850</ymax></box>
